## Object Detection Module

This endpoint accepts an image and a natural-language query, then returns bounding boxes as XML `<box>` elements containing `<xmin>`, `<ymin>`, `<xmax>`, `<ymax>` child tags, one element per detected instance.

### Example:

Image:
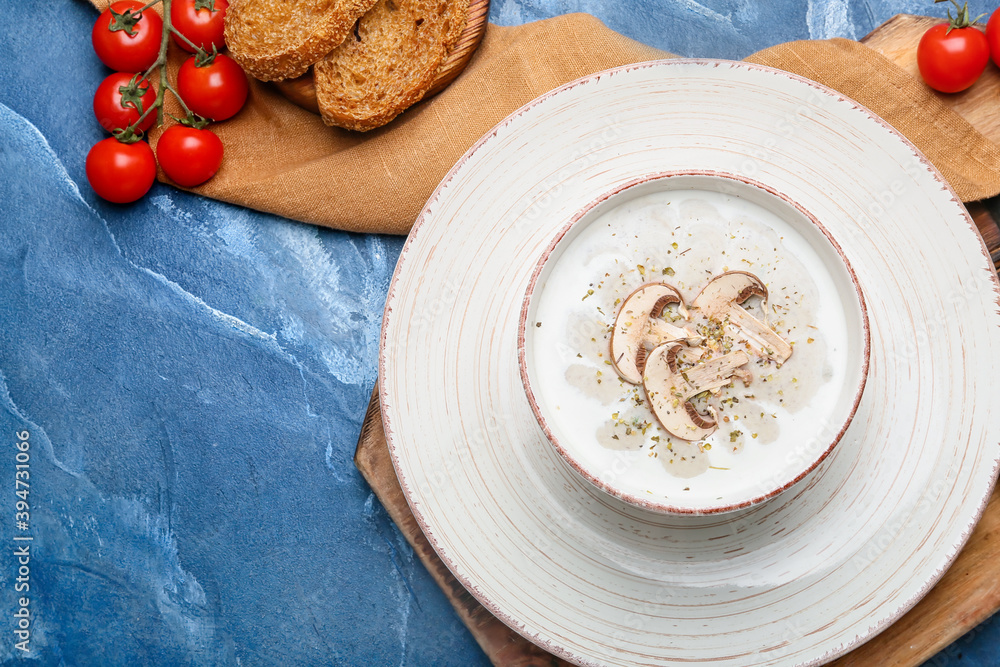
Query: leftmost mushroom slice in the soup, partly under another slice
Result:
<box><xmin>611</xmin><ymin>283</ymin><xmax>701</xmax><ymax>384</ymax></box>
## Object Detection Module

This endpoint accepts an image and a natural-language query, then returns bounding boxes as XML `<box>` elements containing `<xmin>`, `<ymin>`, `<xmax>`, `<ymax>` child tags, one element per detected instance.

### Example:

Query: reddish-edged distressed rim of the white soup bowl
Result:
<box><xmin>517</xmin><ymin>170</ymin><xmax>871</xmax><ymax>514</ymax></box>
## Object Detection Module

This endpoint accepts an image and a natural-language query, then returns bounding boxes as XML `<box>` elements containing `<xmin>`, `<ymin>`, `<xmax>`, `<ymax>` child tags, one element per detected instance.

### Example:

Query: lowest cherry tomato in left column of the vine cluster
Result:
<box><xmin>87</xmin><ymin>137</ymin><xmax>156</xmax><ymax>204</ymax></box>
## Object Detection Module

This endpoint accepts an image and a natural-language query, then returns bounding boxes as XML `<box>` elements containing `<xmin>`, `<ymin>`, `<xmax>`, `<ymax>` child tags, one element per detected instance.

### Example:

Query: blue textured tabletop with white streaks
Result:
<box><xmin>0</xmin><ymin>0</ymin><xmax>1000</xmax><ymax>667</ymax></box>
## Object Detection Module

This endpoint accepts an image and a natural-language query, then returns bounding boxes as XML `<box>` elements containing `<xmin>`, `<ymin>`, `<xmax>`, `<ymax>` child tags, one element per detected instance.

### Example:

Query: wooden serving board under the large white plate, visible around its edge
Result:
<box><xmin>354</xmin><ymin>15</ymin><xmax>1000</xmax><ymax>667</ymax></box>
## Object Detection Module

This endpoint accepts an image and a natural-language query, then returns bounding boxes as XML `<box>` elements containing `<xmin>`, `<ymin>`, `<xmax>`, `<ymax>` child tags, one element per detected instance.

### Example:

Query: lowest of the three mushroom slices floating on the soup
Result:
<box><xmin>642</xmin><ymin>342</ymin><xmax>753</xmax><ymax>440</ymax></box>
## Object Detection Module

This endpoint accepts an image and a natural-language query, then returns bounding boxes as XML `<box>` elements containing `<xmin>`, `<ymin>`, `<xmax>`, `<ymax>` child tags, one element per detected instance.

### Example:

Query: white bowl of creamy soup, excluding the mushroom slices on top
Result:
<box><xmin>518</xmin><ymin>171</ymin><xmax>869</xmax><ymax>514</ymax></box>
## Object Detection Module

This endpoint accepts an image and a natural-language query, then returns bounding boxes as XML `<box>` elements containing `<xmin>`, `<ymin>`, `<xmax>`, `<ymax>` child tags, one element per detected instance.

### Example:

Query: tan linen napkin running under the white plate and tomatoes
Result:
<box><xmin>91</xmin><ymin>5</ymin><xmax>1000</xmax><ymax>234</ymax></box>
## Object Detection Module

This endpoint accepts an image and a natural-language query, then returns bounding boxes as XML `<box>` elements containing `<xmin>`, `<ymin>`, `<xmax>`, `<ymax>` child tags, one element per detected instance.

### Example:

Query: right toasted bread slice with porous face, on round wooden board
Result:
<box><xmin>313</xmin><ymin>0</ymin><xmax>469</xmax><ymax>131</ymax></box>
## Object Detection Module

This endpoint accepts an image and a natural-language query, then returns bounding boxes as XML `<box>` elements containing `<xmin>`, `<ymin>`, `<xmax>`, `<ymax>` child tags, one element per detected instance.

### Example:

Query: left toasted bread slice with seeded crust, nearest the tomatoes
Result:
<box><xmin>226</xmin><ymin>0</ymin><xmax>376</xmax><ymax>81</ymax></box>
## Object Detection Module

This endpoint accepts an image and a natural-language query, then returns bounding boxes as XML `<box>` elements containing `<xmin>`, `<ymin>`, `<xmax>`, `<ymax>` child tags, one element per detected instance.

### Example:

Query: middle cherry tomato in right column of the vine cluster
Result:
<box><xmin>177</xmin><ymin>56</ymin><xmax>250</xmax><ymax>120</ymax></box>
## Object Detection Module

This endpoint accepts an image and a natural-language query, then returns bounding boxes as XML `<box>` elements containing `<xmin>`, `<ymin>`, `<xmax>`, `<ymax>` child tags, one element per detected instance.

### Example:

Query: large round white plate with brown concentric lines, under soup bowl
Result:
<box><xmin>380</xmin><ymin>61</ymin><xmax>1000</xmax><ymax>666</ymax></box>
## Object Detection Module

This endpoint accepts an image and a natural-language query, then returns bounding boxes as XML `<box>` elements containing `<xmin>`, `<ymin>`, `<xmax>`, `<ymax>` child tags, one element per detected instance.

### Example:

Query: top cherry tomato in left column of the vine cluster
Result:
<box><xmin>90</xmin><ymin>0</ymin><xmax>163</xmax><ymax>72</ymax></box>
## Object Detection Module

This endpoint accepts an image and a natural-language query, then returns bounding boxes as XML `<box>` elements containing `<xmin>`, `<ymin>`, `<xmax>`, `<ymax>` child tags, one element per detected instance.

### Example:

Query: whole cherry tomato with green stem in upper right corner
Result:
<box><xmin>917</xmin><ymin>23</ymin><xmax>990</xmax><ymax>93</ymax></box>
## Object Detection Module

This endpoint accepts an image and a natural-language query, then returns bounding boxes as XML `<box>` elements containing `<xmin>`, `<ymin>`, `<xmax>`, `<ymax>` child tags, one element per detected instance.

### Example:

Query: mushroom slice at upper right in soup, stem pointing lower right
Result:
<box><xmin>694</xmin><ymin>271</ymin><xmax>792</xmax><ymax>365</ymax></box>
